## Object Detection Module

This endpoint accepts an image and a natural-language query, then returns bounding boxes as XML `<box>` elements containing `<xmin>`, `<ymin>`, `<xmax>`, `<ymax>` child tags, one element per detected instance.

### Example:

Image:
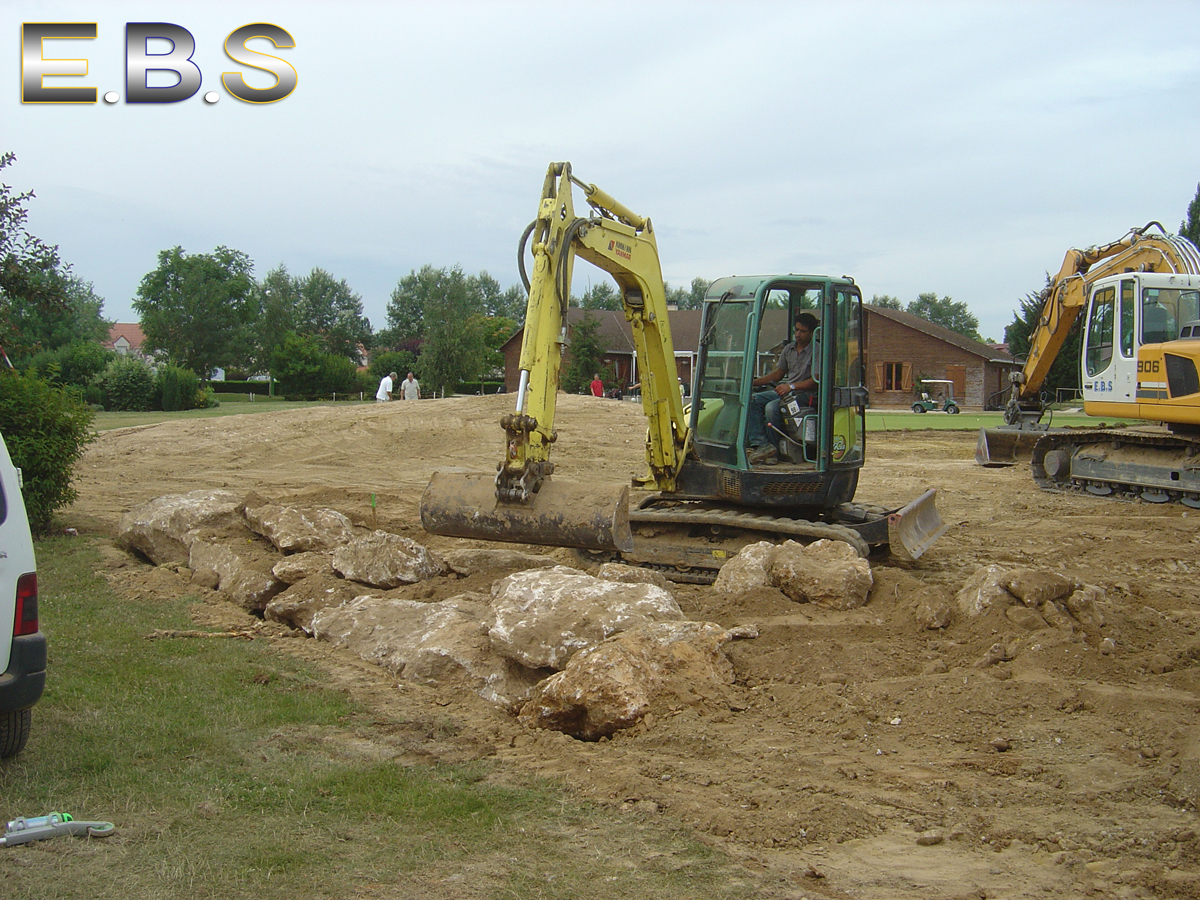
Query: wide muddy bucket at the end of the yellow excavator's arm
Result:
<box><xmin>421</xmin><ymin>472</ymin><xmax>634</xmax><ymax>552</ymax></box>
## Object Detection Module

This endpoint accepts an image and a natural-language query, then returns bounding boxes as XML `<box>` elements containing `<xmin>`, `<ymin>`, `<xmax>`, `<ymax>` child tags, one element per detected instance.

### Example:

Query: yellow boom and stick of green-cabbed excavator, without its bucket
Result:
<box><xmin>496</xmin><ymin>162</ymin><xmax>689</xmax><ymax>503</ymax></box>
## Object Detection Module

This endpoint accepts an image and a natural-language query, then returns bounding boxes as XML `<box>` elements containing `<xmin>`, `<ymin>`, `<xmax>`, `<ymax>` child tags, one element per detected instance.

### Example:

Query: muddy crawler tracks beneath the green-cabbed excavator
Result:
<box><xmin>580</xmin><ymin>500</ymin><xmax>892</xmax><ymax>584</ymax></box>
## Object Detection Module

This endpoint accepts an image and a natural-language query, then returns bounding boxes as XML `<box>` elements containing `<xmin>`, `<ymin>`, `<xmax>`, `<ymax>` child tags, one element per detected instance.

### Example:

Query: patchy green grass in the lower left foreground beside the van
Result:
<box><xmin>0</xmin><ymin>538</ymin><xmax>754</xmax><ymax>900</ymax></box>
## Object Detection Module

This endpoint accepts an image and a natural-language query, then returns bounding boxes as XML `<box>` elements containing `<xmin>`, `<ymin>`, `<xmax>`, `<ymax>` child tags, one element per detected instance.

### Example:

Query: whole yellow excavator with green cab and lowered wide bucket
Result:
<box><xmin>421</xmin><ymin>162</ymin><xmax>944</xmax><ymax>583</ymax></box>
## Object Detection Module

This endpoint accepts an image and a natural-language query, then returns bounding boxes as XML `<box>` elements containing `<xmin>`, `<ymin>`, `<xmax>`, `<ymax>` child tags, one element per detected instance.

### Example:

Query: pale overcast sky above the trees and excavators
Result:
<box><xmin>7</xmin><ymin>0</ymin><xmax>1200</xmax><ymax>340</ymax></box>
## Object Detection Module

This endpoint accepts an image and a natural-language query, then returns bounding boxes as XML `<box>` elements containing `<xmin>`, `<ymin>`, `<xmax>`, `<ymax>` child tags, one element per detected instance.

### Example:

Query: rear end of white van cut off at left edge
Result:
<box><xmin>0</xmin><ymin>436</ymin><xmax>46</xmax><ymax>757</ymax></box>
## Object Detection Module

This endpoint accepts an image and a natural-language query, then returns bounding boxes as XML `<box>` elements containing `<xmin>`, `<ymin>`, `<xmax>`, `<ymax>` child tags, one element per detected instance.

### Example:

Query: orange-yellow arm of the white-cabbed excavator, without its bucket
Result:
<box><xmin>1004</xmin><ymin>222</ymin><xmax>1200</xmax><ymax>425</ymax></box>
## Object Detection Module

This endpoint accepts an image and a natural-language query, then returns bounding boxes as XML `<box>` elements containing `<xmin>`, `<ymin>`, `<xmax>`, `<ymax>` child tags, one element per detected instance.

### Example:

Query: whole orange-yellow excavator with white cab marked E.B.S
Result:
<box><xmin>976</xmin><ymin>222</ymin><xmax>1200</xmax><ymax>506</ymax></box>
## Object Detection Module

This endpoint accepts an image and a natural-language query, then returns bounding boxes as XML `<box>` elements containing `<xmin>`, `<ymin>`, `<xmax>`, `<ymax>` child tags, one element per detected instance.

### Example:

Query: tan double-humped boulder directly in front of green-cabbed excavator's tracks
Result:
<box><xmin>713</xmin><ymin>540</ymin><xmax>872</xmax><ymax>610</ymax></box>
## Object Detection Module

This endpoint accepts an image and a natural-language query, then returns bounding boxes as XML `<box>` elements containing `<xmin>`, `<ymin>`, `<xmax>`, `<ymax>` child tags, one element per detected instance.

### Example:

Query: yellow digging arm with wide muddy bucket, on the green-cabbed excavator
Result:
<box><xmin>421</xmin><ymin>162</ymin><xmax>690</xmax><ymax>551</ymax></box>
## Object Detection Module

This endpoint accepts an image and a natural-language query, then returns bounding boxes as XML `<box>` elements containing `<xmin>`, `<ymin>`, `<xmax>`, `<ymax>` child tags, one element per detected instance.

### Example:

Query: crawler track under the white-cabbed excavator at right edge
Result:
<box><xmin>1031</xmin><ymin>430</ymin><xmax>1200</xmax><ymax>509</ymax></box>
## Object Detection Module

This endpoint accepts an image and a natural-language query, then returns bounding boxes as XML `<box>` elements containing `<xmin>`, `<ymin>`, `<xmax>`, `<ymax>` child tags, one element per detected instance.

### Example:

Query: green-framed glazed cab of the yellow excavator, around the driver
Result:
<box><xmin>680</xmin><ymin>275</ymin><xmax>866</xmax><ymax>509</ymax></box>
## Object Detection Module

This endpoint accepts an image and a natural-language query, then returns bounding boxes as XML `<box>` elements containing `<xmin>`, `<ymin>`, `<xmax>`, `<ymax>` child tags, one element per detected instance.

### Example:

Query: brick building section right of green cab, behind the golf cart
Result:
<box><xmin>863</xmin><ymin>304</ymin><xmax>1016</xmax><ymax>409</ymax></box>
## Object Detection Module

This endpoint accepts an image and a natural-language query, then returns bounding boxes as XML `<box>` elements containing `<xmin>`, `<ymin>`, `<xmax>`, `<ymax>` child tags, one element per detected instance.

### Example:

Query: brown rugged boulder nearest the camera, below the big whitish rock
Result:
<box><xmin>518</xmin><ymin>622</ymin><xmax>740</xmax><ymax>740</ymax></box>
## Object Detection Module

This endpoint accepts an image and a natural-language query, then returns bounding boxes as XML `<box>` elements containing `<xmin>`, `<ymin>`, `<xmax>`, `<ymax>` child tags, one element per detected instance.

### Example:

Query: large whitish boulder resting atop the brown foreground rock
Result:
<box><xmin>488</xmin><ymin>565</ymin><xmax>683</xmax><ymax>668</ymax></box>
